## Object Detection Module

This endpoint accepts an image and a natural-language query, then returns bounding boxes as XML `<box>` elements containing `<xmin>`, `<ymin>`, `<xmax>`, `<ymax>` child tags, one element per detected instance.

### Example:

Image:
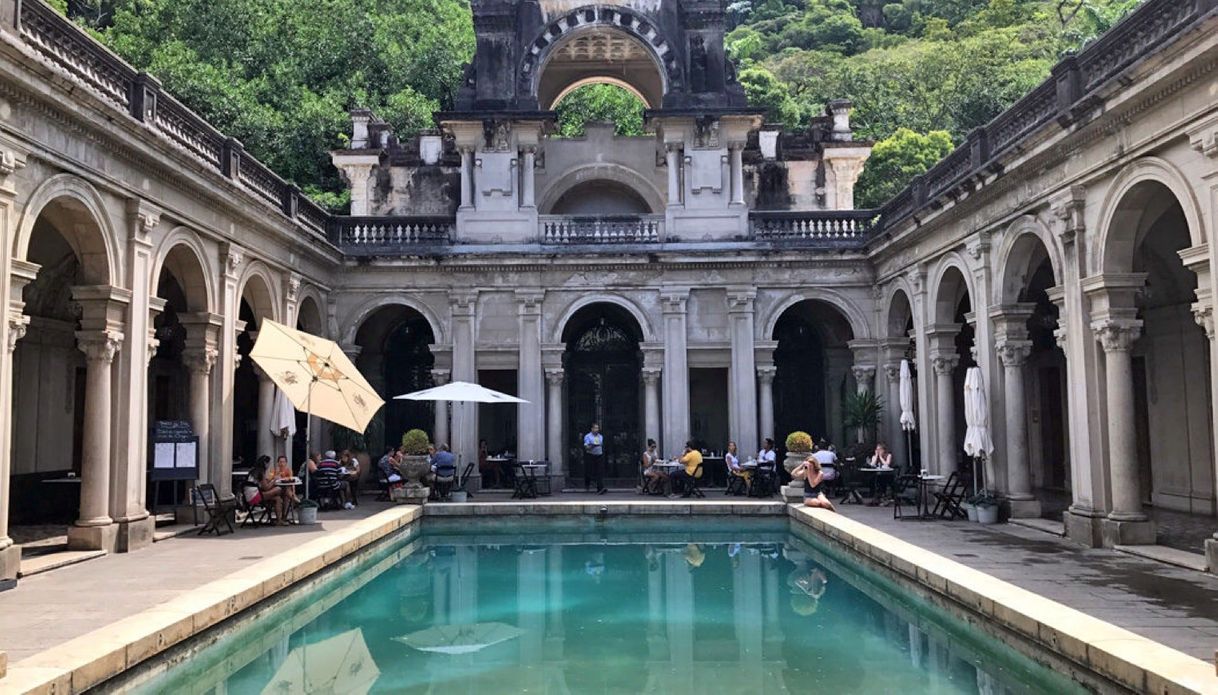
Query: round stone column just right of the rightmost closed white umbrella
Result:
<box><xmin>998</xmin><ymin>340</ymin><xmax>1040</xmax><ymax>519</ymax></box>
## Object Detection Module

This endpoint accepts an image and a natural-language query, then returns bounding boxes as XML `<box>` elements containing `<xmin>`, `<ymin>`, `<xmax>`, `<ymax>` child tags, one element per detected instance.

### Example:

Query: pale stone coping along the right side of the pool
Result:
<box><xmin>788</xmin><ymin>505</ymin><xmax>1218</xmax><ymax>694</ymax></box>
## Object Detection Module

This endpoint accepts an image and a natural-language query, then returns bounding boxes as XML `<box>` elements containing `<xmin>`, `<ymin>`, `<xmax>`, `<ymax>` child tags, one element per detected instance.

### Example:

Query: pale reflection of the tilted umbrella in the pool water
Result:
<box><xmin>262</xmin><ymin>628</ymin><xmax>380</xmax><ymax>695</ymax></box>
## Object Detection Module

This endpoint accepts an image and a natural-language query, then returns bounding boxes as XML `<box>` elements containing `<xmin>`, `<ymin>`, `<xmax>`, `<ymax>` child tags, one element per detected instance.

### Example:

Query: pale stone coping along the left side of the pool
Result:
<box><xmin>0</xmin><ymin>505</ymin><xmax>423</xmax><ymax>694</ymax></box>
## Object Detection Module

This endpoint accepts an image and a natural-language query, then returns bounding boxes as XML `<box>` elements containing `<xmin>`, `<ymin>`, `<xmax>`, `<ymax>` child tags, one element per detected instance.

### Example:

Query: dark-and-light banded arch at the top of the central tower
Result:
<box><xmin>518</xmin><ymin>5</ymin><xmax>685</xmax><ymax>108</ymax></box>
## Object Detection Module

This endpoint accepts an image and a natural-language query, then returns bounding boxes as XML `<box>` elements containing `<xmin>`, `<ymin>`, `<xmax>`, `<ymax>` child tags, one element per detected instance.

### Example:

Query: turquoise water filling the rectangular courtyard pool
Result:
<box><xmin>114</xmin><ymin>517</ymin><xmax>1082</xmax><ymax>695</ymax></box>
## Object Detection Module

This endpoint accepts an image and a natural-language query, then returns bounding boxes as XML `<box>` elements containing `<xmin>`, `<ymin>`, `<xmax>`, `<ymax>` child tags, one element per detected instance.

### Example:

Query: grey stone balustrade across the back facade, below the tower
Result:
<box><xmin>330</xmin><ymin>211</ymin><xmax>877</xmax><ymax>257</ymax></box>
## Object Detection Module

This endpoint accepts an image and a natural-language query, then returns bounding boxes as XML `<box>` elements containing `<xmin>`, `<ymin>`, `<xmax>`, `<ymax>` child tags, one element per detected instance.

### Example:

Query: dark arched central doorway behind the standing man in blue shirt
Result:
<box><xmin>563</xmin><ymin>304</ymin><xmax>643</xmax><ymax>487</ymax></box>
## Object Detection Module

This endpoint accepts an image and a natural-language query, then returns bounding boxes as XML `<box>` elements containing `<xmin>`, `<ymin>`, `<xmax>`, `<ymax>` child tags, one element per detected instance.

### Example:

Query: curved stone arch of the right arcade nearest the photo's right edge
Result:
<box><xmin>1095</xmin><ymin>157</ymin><xmax>1207</xmax><ymax>273</ymax></box>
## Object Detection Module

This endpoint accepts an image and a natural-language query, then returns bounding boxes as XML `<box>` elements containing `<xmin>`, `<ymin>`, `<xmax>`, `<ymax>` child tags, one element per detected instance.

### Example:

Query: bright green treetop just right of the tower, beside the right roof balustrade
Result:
<box><xmin>854</xmin><ymin>128</ymin><xmax>954</xmax><ymax>208</ymax></box>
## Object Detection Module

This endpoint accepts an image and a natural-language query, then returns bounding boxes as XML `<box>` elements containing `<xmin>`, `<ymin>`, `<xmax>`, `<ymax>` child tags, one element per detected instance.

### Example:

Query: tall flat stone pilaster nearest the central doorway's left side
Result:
<box><xmin>516</xmin><ymin>289</ymin><xmax>546</xmax><ymax>460</ymax></box>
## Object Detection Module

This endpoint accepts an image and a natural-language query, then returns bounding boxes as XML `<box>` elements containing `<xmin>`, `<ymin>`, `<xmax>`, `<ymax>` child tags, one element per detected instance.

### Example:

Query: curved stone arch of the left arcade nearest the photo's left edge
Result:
<box><xmin>12</xmin><ymin>174</ymin><xmax>123</xmax><ymax>285</ymax></box>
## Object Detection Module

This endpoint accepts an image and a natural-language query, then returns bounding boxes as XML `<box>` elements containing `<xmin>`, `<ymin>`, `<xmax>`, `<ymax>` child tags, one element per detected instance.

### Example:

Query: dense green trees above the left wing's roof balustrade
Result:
<box><xmin>84</xmin><ymin>0</ymin><xmax>474</xmax><ymax>209</ymax></box>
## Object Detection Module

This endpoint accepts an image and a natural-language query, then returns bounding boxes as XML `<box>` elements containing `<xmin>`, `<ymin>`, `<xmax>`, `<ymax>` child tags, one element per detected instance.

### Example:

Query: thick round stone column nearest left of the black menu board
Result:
<box><xmin>68</xmin><ymin>331</ymin><xmax>123</xmax><ymax>550</ymax></box>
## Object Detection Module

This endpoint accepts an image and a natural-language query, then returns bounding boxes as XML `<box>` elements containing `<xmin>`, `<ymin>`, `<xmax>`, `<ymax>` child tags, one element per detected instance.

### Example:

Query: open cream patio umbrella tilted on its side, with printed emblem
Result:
<box><xmin>250</xmin><ymin>319</ymin><xmax>385</xmax><ymax>491</ymax></box>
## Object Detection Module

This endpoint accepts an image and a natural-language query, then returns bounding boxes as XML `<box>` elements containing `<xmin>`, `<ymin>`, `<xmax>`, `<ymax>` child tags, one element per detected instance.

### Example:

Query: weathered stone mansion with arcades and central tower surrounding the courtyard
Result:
<box><xmin>0</xmin><ymin>0</ymin><xmax>1218</xmax><ymax>578</ymax></box>
